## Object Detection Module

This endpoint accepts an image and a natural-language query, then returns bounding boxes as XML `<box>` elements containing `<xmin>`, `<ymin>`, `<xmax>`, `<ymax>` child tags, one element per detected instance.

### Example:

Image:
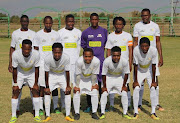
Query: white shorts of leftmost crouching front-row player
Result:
<box><xmin>13</xmin><ymin>72</ymin><xmax>35</xmax><ymax>89</ymax></box>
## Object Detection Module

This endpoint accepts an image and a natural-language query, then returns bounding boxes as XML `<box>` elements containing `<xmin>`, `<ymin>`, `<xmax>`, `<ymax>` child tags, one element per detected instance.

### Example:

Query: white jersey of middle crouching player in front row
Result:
<box><xmin>76</xmin><ymin>56</ymin><xmax>100</xmax><ymax>78</ymax></box>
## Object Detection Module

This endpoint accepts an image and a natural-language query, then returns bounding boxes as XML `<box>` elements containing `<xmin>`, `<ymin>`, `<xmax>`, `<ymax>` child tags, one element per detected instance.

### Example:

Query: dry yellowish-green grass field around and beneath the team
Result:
<box><xmin>0</xmin><ymin>37</ymin><xmax>180</xmax><ymax>123</ymax></box>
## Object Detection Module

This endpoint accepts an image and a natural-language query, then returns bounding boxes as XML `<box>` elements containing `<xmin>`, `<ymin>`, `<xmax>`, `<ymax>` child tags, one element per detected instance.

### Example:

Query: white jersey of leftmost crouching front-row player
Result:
<box><xmin>12</xmin><ymin>49</ymin><xmax>40</xmax><ymax>74</ymax></box>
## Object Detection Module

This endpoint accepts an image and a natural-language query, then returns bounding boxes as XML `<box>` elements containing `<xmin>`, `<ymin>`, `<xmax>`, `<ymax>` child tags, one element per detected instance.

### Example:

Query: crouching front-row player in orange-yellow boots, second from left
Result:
<box><xmin>44</xmin><ymin>43</ymin><xmax>74</xmax><ymax>122</ymax></box>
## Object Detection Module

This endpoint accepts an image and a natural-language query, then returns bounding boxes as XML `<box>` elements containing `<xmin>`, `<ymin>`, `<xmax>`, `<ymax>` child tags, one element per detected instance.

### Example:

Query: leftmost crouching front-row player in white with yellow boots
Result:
<box><xmin>9</xmin><ymin>39</ymin><xmax>41</xmax><ymax>123</ymax></box>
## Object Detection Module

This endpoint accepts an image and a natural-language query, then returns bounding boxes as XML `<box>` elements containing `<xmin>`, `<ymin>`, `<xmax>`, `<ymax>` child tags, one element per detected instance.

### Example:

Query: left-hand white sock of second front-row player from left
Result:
<box><xmin>44</xmin><ymin>95</ymin><xmax>51</xmax><ymax>117</ymax></box>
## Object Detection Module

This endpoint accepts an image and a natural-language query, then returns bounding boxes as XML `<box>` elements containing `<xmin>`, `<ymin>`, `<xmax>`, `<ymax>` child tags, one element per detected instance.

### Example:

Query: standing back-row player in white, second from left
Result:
<box><xmin>34</xmin><ymin>16</ymin><xmax>60</xmax><ymax>115</ymax></box>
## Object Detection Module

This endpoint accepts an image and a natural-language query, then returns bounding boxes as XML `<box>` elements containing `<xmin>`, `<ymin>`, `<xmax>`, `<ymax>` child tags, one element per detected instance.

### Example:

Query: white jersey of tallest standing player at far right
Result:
<box><xmin>133</xmin><ymin>21</ymin><xmax>160</xmax><ymax>47</ymax></box>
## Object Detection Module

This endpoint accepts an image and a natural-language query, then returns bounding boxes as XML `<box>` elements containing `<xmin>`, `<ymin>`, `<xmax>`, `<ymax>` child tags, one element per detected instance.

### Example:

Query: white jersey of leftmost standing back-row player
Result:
<box><xmin>11</xmin><ymin>29</ymin><xmax>36</xmax><ymax>50</ymax></box>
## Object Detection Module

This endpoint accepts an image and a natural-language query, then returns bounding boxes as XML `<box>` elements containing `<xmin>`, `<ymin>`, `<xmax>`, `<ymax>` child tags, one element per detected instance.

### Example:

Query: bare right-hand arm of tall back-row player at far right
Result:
<box><xmin>156</xmin><ymin>36</ymin><xmax>163</xmax><ymax>67</ymax></box>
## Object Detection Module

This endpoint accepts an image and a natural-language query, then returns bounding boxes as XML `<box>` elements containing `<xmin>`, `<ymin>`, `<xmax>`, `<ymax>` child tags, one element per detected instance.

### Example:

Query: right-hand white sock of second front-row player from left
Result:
<box><xmin>63</xmin><ymin>92</ymin><xmax>71</xmax><ymax>116</ymax></box>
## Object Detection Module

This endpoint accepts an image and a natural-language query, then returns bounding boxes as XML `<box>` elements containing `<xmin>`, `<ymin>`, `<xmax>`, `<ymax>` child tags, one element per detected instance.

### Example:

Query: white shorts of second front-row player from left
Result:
<box><xmin>49</xmin><ymin>73</ymin><xmax>67</xmax><ymax>92</ymax></box>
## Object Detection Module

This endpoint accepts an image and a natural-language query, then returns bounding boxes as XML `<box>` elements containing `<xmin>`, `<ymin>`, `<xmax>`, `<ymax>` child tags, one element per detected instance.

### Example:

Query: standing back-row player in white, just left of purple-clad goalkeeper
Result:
<box><xmin>57</xmin><ymin>14</ymin><xmax>81</xmax><ymax>112</ymax></box>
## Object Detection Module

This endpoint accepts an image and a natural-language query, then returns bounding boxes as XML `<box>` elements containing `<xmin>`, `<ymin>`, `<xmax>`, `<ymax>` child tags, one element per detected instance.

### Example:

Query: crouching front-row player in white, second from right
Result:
<box><xmin>100</xmin><ymin>46</ymin><xmax>131</xmax><ymax>119</ymax></box>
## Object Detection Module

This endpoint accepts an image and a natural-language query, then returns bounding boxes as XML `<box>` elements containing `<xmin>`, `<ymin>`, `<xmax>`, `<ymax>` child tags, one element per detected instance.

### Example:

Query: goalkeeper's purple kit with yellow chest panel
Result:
<box><xmin>81</xmin><ymin>26</ymin><xmax>108</xmax><ymax>81</ymax></box>
